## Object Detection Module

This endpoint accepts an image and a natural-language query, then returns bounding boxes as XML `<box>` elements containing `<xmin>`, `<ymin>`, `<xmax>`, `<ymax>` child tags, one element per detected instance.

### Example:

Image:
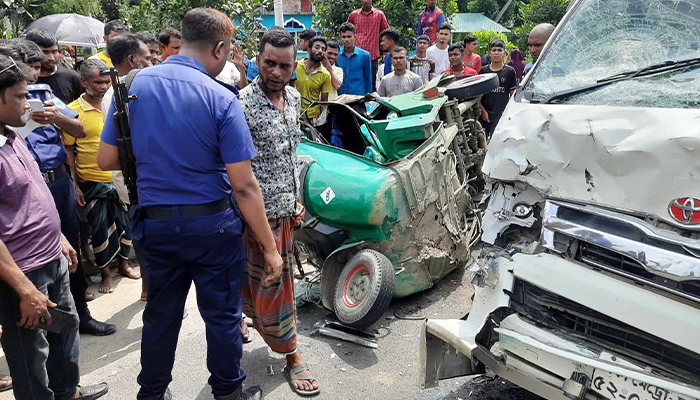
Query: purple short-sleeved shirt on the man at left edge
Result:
<box><xmin>0</xmin><ymin>129</ymin><xmax>61</xmax><ymax>274</ymax></box>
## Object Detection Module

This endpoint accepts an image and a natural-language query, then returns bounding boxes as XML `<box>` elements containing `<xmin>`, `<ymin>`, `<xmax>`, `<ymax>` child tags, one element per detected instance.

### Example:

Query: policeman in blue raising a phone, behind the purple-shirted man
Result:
<box><xmin>10</xmin><ymin>40</ymin><xmax>117</xmax><ymax>336</ymax></box>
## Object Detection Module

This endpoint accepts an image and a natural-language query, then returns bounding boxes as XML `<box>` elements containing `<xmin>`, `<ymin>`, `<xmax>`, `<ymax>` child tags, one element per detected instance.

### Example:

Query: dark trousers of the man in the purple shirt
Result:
<box><xmin>0</xmin><ymin>257</ymin><xmax>80</xmax><ymax>400</ymax></box>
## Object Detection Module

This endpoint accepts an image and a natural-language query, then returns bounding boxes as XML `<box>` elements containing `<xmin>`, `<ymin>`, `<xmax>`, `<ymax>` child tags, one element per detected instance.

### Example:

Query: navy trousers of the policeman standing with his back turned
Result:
<box><xmin>132</xmin><ymin>207</ymin><xmax>246</xmax><ymax>400</ymax></box>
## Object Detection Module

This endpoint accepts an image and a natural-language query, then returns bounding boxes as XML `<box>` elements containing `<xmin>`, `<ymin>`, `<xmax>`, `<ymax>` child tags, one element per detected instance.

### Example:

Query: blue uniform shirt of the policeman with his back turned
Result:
<box><xmin>101</xmin><ymin>55</ymin><xmax>256</xmax><ymax>207</ymax></box>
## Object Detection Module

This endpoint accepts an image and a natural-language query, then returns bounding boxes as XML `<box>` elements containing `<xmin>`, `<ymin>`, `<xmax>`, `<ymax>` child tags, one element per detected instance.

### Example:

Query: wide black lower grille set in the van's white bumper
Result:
<box><xmin>509</xmin><ymin>279</ymin><xmax>700</xmax><ymax>383</ymax></box>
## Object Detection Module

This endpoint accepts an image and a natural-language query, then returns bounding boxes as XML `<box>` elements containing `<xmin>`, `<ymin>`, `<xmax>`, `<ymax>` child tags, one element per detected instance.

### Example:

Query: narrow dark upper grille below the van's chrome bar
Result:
<box><xmin>576</xmin><ymin>242</ymin><xmax>700</xmax><ymax>301</ymax></box>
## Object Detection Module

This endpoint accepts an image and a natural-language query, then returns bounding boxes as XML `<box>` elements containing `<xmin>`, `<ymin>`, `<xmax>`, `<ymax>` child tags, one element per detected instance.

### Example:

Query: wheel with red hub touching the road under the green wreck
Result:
<box><xmin>333</xmin><ymin>249</ymin><xmax>394</xmax><ymax>328</ymax></box>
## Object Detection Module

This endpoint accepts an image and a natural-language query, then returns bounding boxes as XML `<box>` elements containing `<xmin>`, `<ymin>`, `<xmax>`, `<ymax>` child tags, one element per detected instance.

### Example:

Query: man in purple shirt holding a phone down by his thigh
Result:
<box><xmin>0</xmin><ymin>55</ymin><xmax>108</xmax><ymax>400</ymax></box>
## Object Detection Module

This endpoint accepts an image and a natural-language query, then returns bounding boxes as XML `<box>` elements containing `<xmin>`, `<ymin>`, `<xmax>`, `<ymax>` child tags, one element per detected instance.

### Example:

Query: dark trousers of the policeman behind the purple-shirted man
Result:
<box><xmin>48</xmin><ymin>174</ymin><xmax>92</xmax><ymax>322</ymax></box>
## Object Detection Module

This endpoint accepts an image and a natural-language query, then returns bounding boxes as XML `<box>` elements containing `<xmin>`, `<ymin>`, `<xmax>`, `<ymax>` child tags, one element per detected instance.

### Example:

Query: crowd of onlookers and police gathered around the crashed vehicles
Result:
<box><xmin>0</xmin><ymin>0</ymin><xmax>552</xmax><ymax>400</ymax></box>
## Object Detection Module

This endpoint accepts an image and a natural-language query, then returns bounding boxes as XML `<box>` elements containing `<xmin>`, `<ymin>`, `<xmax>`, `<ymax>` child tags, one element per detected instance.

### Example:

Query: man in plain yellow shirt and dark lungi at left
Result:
<box><xmin>63</xmin><ymin>60</ymin><xmax>141</xmax><ymax>293</ymax></box>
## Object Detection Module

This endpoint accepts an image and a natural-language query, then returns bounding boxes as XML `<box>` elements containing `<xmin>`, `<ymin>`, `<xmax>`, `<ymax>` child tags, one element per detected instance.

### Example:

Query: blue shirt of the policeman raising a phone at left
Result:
<box><xmin>24</xmin><ymin>84</ymin><xmax>78</xmax><ymax>172</ymax></box>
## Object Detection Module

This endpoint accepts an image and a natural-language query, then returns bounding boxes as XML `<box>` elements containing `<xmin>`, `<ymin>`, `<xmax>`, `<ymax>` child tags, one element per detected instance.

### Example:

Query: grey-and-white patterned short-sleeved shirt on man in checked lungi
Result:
<box><xmin>241</xmin><ymin>78</ymin><xmax>301</xmax><ymax>219</ymax></box>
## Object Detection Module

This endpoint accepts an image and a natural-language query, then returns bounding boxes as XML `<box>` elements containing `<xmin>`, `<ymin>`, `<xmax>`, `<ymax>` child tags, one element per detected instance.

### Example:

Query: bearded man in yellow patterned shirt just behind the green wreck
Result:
<box><xmin>297</xmin><ymin>36</ymin><xmax>333</xmax><ymax>123</ymax></box>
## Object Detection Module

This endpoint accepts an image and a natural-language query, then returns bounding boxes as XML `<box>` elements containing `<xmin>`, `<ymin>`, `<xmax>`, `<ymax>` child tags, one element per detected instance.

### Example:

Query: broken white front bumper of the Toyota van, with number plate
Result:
<box><xmin>420</xmin><ymin>253</ymin><xmax>700</xmax><ymax>400</ymax></box>
